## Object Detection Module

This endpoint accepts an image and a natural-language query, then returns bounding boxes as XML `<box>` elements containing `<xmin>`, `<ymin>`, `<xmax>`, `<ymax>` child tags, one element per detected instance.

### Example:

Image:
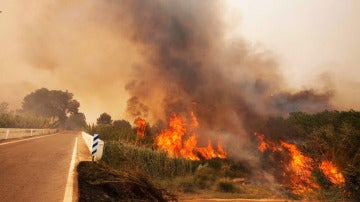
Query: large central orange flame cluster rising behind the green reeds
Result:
<box><xmin>155</xmin><ymin>112</ymin><xmax>226</xmax><ymax>160</ymax></box>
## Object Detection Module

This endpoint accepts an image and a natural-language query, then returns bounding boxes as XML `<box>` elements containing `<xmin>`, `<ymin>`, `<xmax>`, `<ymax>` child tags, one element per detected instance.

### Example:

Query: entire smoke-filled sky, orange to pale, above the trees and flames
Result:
<box><xmin>0</xmin><ymin>0</ymin><xmax>360</xmax><ymax>123</ymax></box>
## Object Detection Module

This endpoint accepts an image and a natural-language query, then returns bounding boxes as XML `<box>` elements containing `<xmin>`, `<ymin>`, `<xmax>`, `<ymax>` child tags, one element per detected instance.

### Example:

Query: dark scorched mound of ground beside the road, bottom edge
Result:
<box><xmin>77</xmin><ymin>162</ymin><xmax>176</xmax><ymax>202</ymax></box>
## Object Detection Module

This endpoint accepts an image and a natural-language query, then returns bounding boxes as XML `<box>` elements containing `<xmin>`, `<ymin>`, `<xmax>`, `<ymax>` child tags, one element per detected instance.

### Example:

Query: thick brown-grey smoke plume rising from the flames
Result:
<box><xmin>112</xmin><ymin>0</ymin><xmax>331</xmax><ymax>134</ymax></box>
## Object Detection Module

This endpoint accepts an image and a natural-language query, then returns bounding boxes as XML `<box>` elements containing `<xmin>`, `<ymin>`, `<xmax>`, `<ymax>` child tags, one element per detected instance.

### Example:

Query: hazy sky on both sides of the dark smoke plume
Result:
<box><xmin>0</xmin><ymin>0</ymin><xmax>360</xmax><ymax>122</ymax></box>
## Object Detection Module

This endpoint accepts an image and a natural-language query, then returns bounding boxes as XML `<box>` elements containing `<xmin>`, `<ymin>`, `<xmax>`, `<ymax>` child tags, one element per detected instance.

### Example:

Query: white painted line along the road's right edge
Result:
<box><xmin>63</xmin><ymin>137</ymin><xmax>77</xmax><ymax>202</ymax></box>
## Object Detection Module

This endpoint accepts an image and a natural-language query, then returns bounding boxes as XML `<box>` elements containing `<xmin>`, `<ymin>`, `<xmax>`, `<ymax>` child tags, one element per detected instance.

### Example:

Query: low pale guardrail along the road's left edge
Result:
<box><xmin>0</xmin><ymin>128</ymin><xmax>58</xmax><ymax>140</ymax></box>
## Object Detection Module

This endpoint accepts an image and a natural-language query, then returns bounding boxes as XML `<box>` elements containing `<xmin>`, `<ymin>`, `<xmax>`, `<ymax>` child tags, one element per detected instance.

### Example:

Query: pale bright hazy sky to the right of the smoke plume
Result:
<box><xmin>228</xmin><ymin>0</ymin><xmax>360</xmax><ymax>110</ymax></box>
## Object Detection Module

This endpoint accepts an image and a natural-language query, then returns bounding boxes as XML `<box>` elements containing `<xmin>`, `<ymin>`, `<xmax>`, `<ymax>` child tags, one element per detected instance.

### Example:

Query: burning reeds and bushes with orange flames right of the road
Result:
<box><xmin>89</xmin><ymin>111</ymin><xmax>360</xmax><ymax>200</ymax></box>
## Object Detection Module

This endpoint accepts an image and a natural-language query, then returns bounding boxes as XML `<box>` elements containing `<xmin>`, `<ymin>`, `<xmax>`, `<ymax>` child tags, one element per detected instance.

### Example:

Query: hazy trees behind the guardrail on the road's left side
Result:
<box><xmin>0</xmin><ymin>88</ymin><xmax>86</xmax><ymax>129</ymax></box>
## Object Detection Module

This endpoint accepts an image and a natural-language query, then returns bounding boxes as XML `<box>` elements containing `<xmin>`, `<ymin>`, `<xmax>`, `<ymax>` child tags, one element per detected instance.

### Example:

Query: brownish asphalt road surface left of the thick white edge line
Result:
<box><xmin>0</xmin><ymin>132</ymin><xmax>77</xmax><ymax>202</ymax></box>
